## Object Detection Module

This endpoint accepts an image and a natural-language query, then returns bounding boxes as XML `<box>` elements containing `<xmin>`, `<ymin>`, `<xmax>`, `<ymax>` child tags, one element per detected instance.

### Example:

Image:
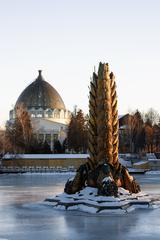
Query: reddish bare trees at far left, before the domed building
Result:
<box><xmin>3</xmin><ymin>105</ymin><xmax>51</xmax><ymax>154</ymax></box>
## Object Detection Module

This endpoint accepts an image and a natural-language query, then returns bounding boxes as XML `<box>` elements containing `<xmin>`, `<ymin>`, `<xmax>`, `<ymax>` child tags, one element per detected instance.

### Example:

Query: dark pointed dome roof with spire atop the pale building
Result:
<box><xmin>15</xmin><ymin>70</ymin><xmax>66</xmax><ymax>109</ymax></box>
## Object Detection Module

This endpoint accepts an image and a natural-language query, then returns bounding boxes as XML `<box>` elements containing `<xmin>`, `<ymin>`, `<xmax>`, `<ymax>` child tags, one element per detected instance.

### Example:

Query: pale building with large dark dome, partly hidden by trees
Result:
<box><xmin>10</xmin><ymin>70</ymin><xmax>70</xmax><ymax>150</ymax></box>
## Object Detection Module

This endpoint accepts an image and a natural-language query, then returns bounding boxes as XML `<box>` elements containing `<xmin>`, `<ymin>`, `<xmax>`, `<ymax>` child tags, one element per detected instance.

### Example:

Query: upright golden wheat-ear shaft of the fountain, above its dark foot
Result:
<box><xmin>89</xmin><ymin>63</ymin><xmax>118</xmax><ymax>168</ymax></box>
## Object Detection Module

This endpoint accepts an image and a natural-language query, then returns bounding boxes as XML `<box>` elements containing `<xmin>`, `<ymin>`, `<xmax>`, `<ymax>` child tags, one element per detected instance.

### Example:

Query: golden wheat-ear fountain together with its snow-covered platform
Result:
<box><xmin>45</xmin><ymin>63</ymin><xmax>160</xmax><ymax>214</ymax></box>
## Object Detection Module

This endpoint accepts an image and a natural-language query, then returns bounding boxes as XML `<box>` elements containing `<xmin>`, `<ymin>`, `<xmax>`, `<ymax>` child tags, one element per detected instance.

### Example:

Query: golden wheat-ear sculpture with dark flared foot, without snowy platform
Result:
<box><xmin>64</xmin><ymin>62</ymin><xmax>140</xmax><ymax>196</ymax></box>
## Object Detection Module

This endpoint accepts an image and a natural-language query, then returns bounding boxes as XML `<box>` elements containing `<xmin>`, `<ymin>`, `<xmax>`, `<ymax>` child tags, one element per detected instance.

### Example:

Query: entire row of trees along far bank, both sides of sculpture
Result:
<box><xmin>0</xmin><ymin>106</ymin><xmax>160</xmax><ymax>153</ymax></box>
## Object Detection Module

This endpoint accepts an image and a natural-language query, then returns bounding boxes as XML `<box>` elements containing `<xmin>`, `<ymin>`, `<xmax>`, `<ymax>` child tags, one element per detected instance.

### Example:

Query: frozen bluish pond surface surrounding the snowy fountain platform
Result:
<box><xmin>0</xmin><ymin>174</ymin><xmax>160</xmax><ymax>240</ymax></box>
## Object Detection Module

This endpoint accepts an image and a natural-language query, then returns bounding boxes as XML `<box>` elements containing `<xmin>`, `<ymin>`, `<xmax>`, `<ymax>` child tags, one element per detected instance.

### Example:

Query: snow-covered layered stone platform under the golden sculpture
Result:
<box><xmin>45</xmin><ymin>187</ymin><xmax>160</xmax><ymax>214</ymax></box>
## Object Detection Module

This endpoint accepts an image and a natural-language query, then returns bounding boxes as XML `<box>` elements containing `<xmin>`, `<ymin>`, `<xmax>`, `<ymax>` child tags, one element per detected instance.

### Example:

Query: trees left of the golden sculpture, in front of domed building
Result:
<box><xmin>0</xmin><ymin>105</ymin><xmax>88</xmax><ymax>154</ymax></box>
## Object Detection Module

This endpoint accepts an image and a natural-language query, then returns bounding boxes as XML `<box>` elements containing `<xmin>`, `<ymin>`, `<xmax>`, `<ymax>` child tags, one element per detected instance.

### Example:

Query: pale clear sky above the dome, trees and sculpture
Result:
<box><xmin>0</xmin><ymin>0</ymin><xmax>160</xmax><ymax>126</ymax></box>
